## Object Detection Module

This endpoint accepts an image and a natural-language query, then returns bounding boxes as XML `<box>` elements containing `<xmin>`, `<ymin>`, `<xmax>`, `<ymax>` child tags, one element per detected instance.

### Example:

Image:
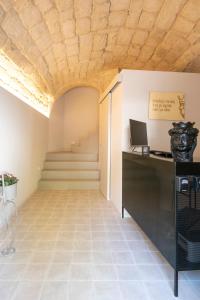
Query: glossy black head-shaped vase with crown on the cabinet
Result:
<box><xmin>168</xmin><ymin>122</ymin><xmax>199</xmax><ymax>162</ymax></box>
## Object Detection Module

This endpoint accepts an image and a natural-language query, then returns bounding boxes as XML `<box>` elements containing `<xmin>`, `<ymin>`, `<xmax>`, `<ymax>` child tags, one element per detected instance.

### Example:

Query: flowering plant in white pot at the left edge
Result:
<box><xmin>0</xmin><ymin>173</ymin><xmax>18</xmax><ymax>201</ymax></box>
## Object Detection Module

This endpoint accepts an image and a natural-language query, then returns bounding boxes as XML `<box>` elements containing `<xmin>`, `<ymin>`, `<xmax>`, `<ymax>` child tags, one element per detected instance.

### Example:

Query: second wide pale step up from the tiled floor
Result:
<box><xmin>42</xmin><ymin>170</ymin><xmax>99</xmax><ymax>179</ymax></box>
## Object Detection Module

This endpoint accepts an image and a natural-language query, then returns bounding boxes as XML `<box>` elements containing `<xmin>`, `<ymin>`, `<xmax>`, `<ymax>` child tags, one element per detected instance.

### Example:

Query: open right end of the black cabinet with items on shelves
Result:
<box><xmin>175</xmin><ymin>170</ymin><xmax>200</xmax><ymax>295</ymax></box>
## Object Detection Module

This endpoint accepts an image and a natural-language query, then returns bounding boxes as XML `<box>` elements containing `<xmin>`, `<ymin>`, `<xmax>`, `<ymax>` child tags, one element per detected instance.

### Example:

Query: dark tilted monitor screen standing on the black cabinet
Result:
<box><xmin>129</xmin><ymin>119</ymin><xmax>148</xmax><ymax>146</ymax></box>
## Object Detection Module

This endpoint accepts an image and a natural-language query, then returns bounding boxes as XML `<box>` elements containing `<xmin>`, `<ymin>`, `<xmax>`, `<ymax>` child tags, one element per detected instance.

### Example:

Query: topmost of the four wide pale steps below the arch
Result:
<box><xmin>46</xmin><ymin>152</ymin><xmax>98</xmax><ymax>161</ymax></box>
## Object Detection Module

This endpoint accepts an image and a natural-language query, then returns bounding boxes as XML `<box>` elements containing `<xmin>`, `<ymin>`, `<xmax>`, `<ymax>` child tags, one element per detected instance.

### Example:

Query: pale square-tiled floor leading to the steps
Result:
<box><xmin>0</xmin><ymin>191</ymin><xmax>200</xmax><ymax>300</ymax></box>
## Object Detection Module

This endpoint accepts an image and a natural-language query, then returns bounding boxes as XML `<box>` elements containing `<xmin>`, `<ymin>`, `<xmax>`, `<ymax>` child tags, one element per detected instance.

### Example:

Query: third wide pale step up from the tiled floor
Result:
<box><xmin>44</xmin><ymin>161</ymin><xmax>98</xmax><ymax>170</ymax></box>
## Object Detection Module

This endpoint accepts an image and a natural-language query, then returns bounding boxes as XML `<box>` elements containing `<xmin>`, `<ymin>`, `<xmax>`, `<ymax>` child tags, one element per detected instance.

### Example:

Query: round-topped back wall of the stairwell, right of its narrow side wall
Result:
<box><xmin>63</xmin><ymin>87</ymin><xmax>99</xmax><ymax>152</ymax></box>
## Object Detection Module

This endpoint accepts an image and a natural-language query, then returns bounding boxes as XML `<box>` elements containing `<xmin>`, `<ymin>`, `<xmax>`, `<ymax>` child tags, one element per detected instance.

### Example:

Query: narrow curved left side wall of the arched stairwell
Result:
<box><xmin>48</xmin><ymin>97</ymin><xmax>64</xmax><ymax>152</ymax></box>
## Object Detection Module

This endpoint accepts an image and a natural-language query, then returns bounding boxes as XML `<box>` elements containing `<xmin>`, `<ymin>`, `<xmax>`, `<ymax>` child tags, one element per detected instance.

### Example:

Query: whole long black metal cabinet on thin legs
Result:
<box><xmin>122</xmin><ymin>152</ymin><xmax>200</xmax><ymax>296</ymax></box>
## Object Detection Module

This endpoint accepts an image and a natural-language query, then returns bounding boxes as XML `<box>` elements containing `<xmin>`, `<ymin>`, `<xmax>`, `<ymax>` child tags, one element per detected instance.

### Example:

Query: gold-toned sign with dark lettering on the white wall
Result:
<box><xmin>149</xmin><ymin>92</ymin><xmax>185</xmax><ymax>121</ymax></box>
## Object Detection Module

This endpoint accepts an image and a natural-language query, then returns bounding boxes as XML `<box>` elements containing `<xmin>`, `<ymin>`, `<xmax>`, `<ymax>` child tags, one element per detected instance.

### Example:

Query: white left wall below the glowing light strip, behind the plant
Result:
<box><xmin>0</xmin><ymin>88</ymin><xmax>48</xmax><ymax>205</ymax></box>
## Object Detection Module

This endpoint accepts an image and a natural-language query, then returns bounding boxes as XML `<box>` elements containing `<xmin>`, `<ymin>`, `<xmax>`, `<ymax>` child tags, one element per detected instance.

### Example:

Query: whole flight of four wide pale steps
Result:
<box><xmin>39</xmin><ymin>152</ymin><xmax>99</xmax><ymax>190</ymax></box>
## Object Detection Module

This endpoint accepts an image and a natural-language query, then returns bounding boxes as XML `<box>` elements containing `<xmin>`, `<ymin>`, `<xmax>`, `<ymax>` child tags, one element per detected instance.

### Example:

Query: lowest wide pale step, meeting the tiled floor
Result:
<box><xmin>39</xmin><ymin>179</ymin><xmax>99</xmax><ymax>190</ymax></box>
